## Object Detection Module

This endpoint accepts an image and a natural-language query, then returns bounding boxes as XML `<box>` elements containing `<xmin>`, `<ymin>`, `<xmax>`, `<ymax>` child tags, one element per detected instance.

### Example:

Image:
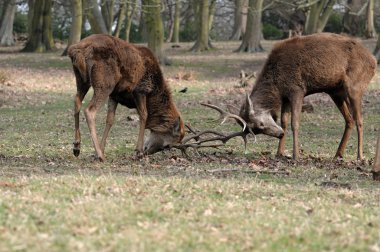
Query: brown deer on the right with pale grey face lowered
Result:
<box><xmin>240</xmin><ymin>33</ymin><xmax>376</xmax><ymax>160</ymax></box>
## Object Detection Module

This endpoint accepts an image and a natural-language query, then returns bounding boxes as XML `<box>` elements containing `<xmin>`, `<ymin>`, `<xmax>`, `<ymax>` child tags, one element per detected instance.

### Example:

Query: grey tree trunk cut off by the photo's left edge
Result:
<box><xmin>0</xmin><ymin>0</ymin><xmax>17</xmax><ymax>46</ymax></box>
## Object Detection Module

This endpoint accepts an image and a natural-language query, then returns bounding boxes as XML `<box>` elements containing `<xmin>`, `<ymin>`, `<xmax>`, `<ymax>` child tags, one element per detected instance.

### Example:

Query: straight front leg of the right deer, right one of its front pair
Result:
<box><xmin>291</xmin><ymin>94</ymin><xmax>303</xmax><ymax>160</ymax></box>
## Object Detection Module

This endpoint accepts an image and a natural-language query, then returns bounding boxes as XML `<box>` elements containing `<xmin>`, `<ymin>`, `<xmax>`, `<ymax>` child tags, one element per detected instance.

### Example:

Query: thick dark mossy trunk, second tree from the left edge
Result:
<box><xmin>23</xmin><ymin>0</ymin><xmax>55</xmax><ymax>52</ymax></box>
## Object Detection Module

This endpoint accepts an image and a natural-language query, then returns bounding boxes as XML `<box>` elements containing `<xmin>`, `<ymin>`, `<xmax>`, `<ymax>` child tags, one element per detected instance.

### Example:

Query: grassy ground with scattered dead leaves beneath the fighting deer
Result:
<box><xmin>0</xmin><ymin>40</ymin><xmax>380</xmax><ymax>251</ymax></box>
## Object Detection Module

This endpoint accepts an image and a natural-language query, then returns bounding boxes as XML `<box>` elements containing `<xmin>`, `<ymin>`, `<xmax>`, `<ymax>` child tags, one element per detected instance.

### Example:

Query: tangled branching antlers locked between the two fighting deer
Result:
<box><xmin>170</xmin><ymin>103</ymin><xmax>256</xmax><ymax>156</ymax></box>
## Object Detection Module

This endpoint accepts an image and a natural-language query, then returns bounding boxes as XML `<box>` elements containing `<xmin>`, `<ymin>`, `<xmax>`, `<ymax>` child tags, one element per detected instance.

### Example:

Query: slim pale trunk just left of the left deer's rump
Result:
<box><xmin>62</xmin><ymin>0</ymin><xmax>82</xmax><ymax>56</ymax></box>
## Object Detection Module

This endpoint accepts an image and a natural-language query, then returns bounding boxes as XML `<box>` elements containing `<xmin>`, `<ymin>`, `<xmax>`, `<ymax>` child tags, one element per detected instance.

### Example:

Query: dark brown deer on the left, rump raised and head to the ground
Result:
<box><xmin>68</xmin><ymin>34</ymin><xmax>184</xmax><ymax>161</ymax></box>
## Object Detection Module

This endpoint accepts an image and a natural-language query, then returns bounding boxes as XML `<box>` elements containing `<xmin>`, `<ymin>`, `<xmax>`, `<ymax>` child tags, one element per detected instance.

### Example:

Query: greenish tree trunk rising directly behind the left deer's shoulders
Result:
<box><xmin>142</xmin><ymin>0</ymin><xmax>169</xmax><ymax>64</ymax></box>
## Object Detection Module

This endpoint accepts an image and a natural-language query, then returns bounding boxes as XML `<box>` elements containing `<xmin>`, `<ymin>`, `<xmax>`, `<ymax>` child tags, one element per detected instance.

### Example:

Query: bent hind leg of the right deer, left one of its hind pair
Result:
<box><xmin>330</xmin><ymin>94</ymin><xmax>354</xmax><ymax>158</ymax></box>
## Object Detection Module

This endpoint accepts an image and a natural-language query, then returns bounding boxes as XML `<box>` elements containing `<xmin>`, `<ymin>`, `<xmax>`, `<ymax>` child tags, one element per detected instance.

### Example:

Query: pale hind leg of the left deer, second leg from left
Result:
<box><xmin>84</xmin><ymin>89</ymin><xmax>110</xmax><ymax>161</ymax></box>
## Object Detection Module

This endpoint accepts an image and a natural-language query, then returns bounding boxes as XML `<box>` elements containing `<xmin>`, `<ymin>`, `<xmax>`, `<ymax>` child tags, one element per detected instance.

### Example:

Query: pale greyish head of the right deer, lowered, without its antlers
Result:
<box><xmin>240</xmin><ymin>94</ymin><xmax>284</xmax><ymax>138</ymax></box>
